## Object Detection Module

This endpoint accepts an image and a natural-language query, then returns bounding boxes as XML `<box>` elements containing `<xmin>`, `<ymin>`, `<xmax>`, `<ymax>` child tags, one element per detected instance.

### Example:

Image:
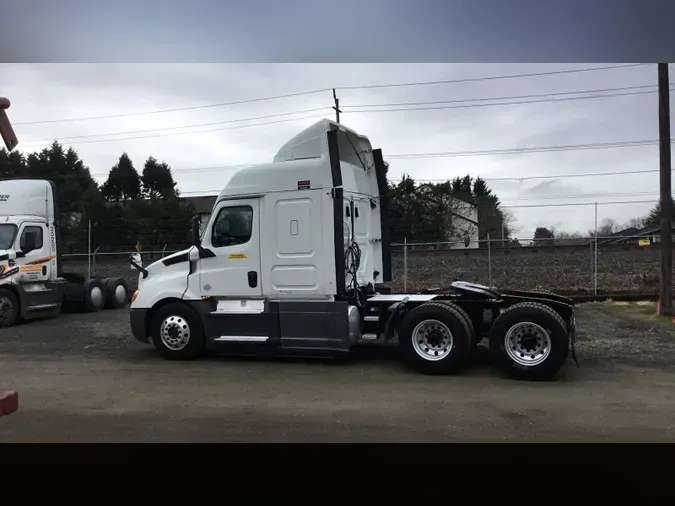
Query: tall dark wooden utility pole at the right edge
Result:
<box><xmin>658</xmin><ymin>63</ymin><xmax>673</xmax><ymax>316</ymax></box>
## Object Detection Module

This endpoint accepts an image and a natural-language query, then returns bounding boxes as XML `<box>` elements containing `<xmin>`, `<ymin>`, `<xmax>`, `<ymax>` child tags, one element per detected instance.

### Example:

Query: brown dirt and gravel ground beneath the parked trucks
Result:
<box><xmin>0</xmin><ymin>304</ymin><xmax>675</xmax><ymax>442</ymax></box>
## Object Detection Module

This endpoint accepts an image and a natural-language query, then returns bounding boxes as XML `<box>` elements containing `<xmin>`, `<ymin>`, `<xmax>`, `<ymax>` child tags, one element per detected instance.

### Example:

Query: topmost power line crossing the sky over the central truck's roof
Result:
<box><xmin>9</xmin><ymin>63</ymin><xmax>650</xmax><ymax>126</ymax></box>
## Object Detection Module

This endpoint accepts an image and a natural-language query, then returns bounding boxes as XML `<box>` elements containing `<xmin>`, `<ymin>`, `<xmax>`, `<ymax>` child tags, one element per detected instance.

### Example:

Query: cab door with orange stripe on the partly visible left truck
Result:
<box><xmin>14</xmin><ymin>222</ymin><xmax>54</xmax><ymax>282</ymax></box>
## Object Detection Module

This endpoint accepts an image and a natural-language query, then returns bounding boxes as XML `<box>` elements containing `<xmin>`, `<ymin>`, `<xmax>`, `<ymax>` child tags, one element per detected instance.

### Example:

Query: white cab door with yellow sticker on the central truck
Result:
<box><xmin>199</xmin><ymin>198</ymin><xmax>262</xmax><ymax>298</ymax></box>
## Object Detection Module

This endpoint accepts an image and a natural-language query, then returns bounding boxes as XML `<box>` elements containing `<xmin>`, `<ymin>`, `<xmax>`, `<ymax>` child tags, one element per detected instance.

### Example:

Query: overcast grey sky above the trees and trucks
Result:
<box><xmin>0</xmin><ymin>63</ymin><xmax>675</xmax><ymax>238</ymax></box>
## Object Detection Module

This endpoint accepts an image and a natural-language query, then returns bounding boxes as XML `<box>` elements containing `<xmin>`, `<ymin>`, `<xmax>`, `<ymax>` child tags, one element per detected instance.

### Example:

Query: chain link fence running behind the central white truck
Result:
<box><xmin>62</xmin><ymin>231</ymin><xmax>660</xmax><ymax>294</ymax></box>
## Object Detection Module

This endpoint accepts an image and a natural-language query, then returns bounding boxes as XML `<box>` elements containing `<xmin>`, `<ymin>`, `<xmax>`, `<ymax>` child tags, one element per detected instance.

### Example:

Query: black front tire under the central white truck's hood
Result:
<box><xmin>151</xmin><ymin>302</ymin><xmax>205</xmax><ymax>360</ymax></box>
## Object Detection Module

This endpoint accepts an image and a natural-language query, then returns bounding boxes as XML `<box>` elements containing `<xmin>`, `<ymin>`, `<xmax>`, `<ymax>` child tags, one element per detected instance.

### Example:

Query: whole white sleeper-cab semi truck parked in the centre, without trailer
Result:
<box><xmin>130</xmin><ymin>120</ymin><xmax>576</xmax><ymax>380</ymax></box>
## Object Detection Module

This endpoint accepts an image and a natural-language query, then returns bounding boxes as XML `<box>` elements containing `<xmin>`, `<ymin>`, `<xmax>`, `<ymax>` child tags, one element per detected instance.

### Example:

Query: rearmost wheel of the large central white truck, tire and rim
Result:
<box><xmin>490</xmin><ymin>302</ymin><xmax>570</xmax><ymax>381</ymax></box>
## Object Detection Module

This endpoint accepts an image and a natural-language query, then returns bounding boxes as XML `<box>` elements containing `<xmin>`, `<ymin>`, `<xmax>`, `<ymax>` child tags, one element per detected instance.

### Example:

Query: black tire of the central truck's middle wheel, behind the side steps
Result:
<box><xmin>398</xmin><ymin>301</ymin><xmax>471</xmax><ymax>374</ymax></box>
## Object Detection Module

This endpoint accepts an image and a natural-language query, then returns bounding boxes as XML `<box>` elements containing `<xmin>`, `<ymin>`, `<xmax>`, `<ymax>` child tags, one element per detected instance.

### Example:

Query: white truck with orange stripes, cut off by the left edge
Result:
<box><xmin>0</xmin><ymin>179</ymin><xmax>129</xmax><ymax>327</ymax></box>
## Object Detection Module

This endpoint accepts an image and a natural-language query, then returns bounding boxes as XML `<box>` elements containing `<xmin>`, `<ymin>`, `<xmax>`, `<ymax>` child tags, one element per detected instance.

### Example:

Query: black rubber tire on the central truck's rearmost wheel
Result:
<box><xmin>490</xmin><ymin>302</ymin><xmax>570</xmax><ymax>381</ymax></box>
